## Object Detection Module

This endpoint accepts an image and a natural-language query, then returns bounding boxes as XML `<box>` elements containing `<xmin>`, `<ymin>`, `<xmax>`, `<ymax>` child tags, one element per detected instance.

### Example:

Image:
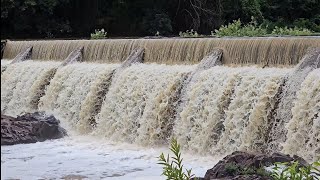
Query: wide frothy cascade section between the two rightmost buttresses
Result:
<box><xmin>174</xmin><ymin>67</ymin><xmax>288</xmax><ymax>154</ymax></box>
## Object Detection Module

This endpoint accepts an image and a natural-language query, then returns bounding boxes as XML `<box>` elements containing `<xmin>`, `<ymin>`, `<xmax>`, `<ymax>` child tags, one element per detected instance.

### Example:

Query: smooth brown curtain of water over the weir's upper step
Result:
<box><xmin>3</xmin><ymin>37</ymin><xmax>320</xmax><ymax>66</ymax></box>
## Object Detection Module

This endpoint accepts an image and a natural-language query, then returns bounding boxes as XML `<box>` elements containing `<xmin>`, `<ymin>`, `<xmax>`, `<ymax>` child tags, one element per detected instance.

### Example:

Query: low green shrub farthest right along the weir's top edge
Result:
<box><xmin>271</xmin><ymin>26</ymin><xmax>312</xmax><ymax>36</ymax></box>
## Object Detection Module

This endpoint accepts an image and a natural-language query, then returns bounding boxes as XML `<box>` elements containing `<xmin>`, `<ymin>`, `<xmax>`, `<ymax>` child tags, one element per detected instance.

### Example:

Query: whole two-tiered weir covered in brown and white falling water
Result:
<box><xmin>1</xmin><ymin>37</ymin><xmax>320</xmax><ymax>160</ymax></box>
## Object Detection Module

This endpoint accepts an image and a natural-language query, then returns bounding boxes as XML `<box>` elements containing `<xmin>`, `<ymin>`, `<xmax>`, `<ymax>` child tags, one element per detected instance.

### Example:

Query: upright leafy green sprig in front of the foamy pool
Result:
<box><xmin>158</xmin><ymin>139</ymin><xmax>194</xmax><ymax>180</ymax></box>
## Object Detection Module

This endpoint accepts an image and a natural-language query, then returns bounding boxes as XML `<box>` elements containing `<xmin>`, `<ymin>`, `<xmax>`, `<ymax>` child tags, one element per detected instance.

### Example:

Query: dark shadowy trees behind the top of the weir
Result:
<box><xmin>1</xmin><ymin>0</ymin><xmax>320</xmax><ymax>39</ymax></box>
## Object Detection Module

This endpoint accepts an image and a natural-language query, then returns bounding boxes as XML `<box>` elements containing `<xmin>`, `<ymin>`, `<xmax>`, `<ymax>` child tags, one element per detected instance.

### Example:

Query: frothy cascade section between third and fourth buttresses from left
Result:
<box><xmin>95</xmin><ymin>64</ymin><xmax>194</xmax><ymax>143</ymax></box>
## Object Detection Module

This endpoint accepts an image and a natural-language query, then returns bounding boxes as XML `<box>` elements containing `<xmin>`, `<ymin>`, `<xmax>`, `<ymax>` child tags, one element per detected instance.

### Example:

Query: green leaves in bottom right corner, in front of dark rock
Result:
<box><xmin>271</xmin><ymin>161</ymin><xmax>320</xmax><ymax>180</ymax></box>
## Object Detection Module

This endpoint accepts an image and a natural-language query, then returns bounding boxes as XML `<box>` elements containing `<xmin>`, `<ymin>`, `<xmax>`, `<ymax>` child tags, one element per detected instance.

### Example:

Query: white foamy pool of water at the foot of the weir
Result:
<box><xmin>1</xmin><ymin>136</ymin><xmax>217</xmax><ymax>179</ymax></box>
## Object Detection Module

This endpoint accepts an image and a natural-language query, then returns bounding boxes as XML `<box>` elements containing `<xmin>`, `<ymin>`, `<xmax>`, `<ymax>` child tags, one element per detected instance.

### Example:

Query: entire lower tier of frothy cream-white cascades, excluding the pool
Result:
<box><xmin>1</xmin><ymin>57</ymin><xmax>320</xmax><ymax>160</ymax></box>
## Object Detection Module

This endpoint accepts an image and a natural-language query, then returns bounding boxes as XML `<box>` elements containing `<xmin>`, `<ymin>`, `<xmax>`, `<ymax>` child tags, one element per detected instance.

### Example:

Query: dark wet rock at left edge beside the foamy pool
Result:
<box><xmin>1</xmin><ymin>112</ymin><xmax>67</xmax><ymax>145</ymax></box>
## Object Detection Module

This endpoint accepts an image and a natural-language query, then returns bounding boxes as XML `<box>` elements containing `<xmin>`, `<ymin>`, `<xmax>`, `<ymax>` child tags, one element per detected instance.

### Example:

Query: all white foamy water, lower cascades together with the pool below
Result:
<box><xmin>1</xmin><ymin>55</ymin><xmax>320</xmax><ymax>179</ymax></box>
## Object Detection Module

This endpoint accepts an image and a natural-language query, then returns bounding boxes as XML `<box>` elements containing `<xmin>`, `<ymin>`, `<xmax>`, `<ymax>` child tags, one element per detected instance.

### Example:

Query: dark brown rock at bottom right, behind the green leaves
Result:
<box><xmin>204</xmin><ymin>151</ymin><xmax>308</xmax><ymax>180</ymax></box>
